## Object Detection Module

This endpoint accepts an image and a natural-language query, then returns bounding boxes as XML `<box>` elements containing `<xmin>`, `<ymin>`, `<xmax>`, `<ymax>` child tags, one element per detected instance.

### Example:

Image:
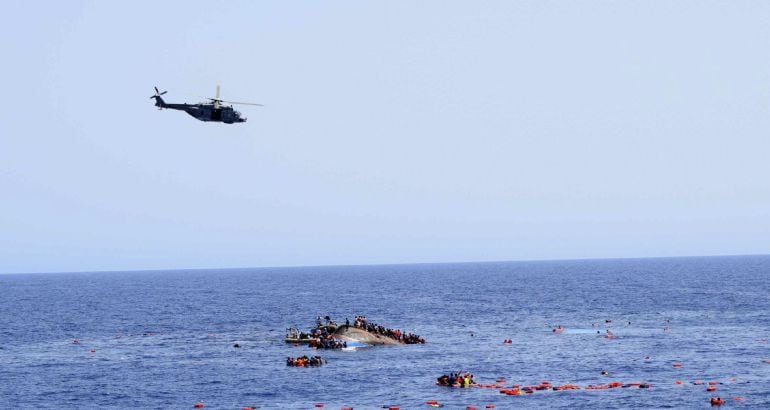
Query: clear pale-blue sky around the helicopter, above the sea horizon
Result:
<box><xmin>0</xmin><ymin>0</ymin><xmax>770</xmax><ymax>273</ymax></box>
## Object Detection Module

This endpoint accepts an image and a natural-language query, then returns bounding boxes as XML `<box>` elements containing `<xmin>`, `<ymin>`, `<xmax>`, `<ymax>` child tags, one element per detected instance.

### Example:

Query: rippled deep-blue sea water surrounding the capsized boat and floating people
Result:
<box><xmin>0</xmin><ymin>256</ymin><xmax>770</xmax><ymax>409</ymax></box>
